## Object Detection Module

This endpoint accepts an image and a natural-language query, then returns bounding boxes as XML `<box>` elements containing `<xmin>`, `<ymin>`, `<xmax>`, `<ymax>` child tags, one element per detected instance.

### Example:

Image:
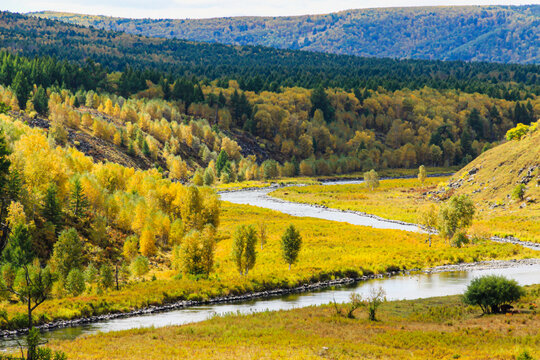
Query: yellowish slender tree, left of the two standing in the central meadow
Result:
<box><xmin>232</xmin><ymin>225</ymin><xmax>258</xmax><ymax>276</ymax></box>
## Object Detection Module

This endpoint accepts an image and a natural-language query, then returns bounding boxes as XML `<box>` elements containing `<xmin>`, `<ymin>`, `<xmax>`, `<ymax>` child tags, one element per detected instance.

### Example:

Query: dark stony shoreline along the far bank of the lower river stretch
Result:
<box><xmin>0</xmin><ymin>258</ymin><xmax>540</xmax><ymax>338</ymax></box>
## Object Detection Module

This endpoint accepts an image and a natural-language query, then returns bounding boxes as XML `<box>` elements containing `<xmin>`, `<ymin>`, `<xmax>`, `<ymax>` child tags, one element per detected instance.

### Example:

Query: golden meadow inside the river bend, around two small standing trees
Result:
<box><xmin>0</xmin><ymin>203</ymin><xmax>537</xmax><ymax>328</ymax></box>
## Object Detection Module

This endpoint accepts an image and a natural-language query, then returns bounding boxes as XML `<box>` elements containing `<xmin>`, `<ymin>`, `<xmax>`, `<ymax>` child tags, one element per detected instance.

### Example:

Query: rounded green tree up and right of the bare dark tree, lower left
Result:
<box><xmin>51</xmin><ymin>228</ymin><xmax>83</xmax><ymax>280</ymax></box>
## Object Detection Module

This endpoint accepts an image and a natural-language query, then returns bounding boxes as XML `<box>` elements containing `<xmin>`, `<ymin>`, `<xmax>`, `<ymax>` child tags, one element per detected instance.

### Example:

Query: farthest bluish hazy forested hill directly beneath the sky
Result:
<box><xmin>30</xmin><ymin>5</ymin><xmax>540</xmax><ymax>63</ymax></box>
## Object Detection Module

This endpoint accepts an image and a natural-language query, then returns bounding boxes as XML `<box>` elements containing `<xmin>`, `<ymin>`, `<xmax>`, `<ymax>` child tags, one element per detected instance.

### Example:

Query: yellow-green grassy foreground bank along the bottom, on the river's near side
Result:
<box><xmin>46</xmin><ymin>286</ymin><xmax>540</xmax><ymax>360</ymax></box>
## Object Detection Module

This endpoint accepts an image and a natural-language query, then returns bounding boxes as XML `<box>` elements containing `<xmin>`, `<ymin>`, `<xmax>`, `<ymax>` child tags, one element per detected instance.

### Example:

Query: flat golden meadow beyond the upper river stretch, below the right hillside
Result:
<box><xmin>270</xmin><ymin>177</ymin><xmax>540</xmax><ymax>242</ymax></box>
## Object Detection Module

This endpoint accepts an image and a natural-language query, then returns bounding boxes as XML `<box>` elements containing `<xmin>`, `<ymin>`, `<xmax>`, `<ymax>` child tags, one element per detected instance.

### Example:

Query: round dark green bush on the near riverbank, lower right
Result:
<box><xmin>463</xmin><ymin>275</ymin><xmax>525</xmax><ymax>314</ymax></box>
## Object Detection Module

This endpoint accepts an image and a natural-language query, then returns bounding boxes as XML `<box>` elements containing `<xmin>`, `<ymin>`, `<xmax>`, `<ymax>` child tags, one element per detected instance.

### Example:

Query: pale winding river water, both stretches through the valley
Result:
<box><xmin>0</xmin><ymin>181</ymin><xmax>540</xmax><ymax>349</ymax></box>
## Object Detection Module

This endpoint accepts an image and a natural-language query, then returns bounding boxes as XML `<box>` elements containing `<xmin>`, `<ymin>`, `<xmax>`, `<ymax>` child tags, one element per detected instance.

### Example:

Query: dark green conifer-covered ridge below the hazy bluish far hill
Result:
<box><xmin>0</xmin><ymin>12</ymin><xmax>540</xmax><ymax>100</ymax></box>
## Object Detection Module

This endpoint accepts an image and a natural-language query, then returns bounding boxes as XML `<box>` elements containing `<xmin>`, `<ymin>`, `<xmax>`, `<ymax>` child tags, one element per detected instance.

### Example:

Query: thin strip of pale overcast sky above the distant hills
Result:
<box><xmin>0</xmin><ymin>0</ymin><xmax>540</xmax><ymax>19</ymax></box>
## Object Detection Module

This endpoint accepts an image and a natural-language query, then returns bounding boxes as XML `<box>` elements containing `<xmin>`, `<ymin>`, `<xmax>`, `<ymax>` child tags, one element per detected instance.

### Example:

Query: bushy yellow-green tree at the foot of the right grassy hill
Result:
<box><xmin>438</xmin><ymin>195</ymin><xmax>475</xmax><ymax>239</ymax></box>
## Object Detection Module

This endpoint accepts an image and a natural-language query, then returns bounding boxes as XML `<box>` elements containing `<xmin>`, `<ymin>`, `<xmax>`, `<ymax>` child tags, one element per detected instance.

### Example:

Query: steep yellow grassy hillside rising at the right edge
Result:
<box><xmin>450</xmin><ymin>127</ymin><xmax>540</xmax><ymax>242</ymax></box>
